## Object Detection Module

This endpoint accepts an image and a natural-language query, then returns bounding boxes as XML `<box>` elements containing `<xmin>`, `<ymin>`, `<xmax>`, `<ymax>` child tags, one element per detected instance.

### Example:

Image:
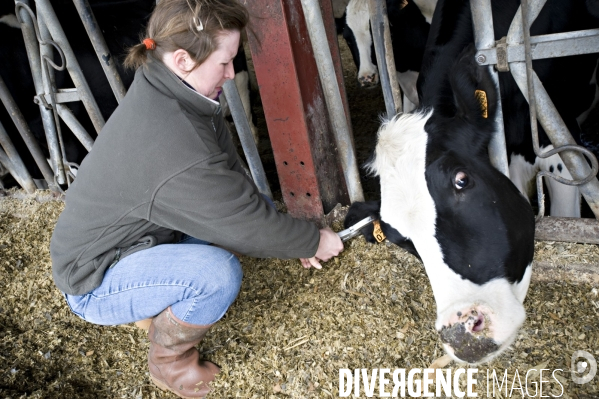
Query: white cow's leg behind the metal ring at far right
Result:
<box><xmin>536</xmin><ymin>146</ymin><xmax>580</xmax><ymax>218</ymax></box>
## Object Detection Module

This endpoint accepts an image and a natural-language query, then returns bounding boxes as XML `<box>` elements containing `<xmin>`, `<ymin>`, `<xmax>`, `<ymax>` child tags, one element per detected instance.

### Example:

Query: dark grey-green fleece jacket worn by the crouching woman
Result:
<box><xmin>50</xmin><ymin>57</ymin><xmax>320</xmax><ymax>295</ymax></box>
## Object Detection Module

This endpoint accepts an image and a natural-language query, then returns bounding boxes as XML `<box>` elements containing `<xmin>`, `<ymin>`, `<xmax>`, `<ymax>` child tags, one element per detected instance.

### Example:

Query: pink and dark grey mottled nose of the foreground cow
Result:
<box><xmin>439</xmin><ymin>305</ymin><xmax>500</xmax><ymax>363</ymax></box>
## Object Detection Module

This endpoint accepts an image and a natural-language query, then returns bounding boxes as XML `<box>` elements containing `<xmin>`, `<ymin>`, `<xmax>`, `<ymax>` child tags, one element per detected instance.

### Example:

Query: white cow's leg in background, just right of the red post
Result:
<box><xmin>346</xmin><ymin>0</ymin><xmax>379</xmax><ymax>87</ymax></box>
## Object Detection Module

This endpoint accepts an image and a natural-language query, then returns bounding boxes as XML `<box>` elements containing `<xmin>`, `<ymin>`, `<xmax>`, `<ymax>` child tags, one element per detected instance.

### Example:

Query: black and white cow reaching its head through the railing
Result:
<box><xmin>345</xmin><ymin>0</ymin><xmax>596</xmax><ymax>363</ymax></box>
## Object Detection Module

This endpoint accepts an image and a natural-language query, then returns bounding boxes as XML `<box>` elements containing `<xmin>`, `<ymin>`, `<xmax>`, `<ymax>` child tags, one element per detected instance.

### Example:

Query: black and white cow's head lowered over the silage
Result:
<box><xmin>369</xmin><ymin>47</ymin><xmax>534</xmax><ymax>363</ymax></box>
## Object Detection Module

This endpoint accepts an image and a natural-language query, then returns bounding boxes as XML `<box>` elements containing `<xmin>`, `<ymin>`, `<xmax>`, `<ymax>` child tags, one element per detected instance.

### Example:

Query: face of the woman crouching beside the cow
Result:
<box><xmin>181</xmin><ymin>31</ymin><xmax>241</xmax><ymax>100</ymax></box>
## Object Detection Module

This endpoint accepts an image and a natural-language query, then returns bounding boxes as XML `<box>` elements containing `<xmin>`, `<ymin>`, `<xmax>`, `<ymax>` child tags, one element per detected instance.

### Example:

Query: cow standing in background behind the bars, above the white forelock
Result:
<box><xmin>343</xmin><ymin>0</ymin><xmax>436</xmax><ymax>112</ymax></box>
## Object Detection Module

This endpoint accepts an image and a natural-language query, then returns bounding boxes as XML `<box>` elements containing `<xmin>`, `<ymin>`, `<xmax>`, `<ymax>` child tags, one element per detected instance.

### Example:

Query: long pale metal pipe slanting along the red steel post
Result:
<box><xmin>302</xmin><ymin>0</ymin><xmax>364</xmax><ymax>202</ymax></box>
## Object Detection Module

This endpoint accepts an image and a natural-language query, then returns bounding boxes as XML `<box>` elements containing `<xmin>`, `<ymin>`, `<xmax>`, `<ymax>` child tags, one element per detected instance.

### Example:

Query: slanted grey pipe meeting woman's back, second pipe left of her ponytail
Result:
<box><xmin>35</xmin><ymin>0</ymin><xmax>105</xmax><ymax>133</ymax></box>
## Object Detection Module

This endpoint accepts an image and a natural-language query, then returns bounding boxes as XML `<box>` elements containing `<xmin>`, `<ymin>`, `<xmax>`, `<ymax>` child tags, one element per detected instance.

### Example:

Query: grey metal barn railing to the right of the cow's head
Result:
<box><xmin>470</xmin><ymin>0</ymin><xmax>599</xmax><ymax>243</ymax></box>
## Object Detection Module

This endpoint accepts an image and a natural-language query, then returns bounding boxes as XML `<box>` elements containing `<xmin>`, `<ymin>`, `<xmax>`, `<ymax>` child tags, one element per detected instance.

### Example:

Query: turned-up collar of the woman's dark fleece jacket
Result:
<box><xmin>138</xmin><ymin>56</ymin><xmax>221</xmax><ymax>116</ymax></box>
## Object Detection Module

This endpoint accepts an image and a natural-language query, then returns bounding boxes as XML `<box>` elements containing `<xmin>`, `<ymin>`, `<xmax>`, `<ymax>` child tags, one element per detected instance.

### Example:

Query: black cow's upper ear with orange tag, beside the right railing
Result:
<box><xmin>449</xmin><ymin>45</ymin><xmax>497</xmax><ymax>128</ymax></box>
